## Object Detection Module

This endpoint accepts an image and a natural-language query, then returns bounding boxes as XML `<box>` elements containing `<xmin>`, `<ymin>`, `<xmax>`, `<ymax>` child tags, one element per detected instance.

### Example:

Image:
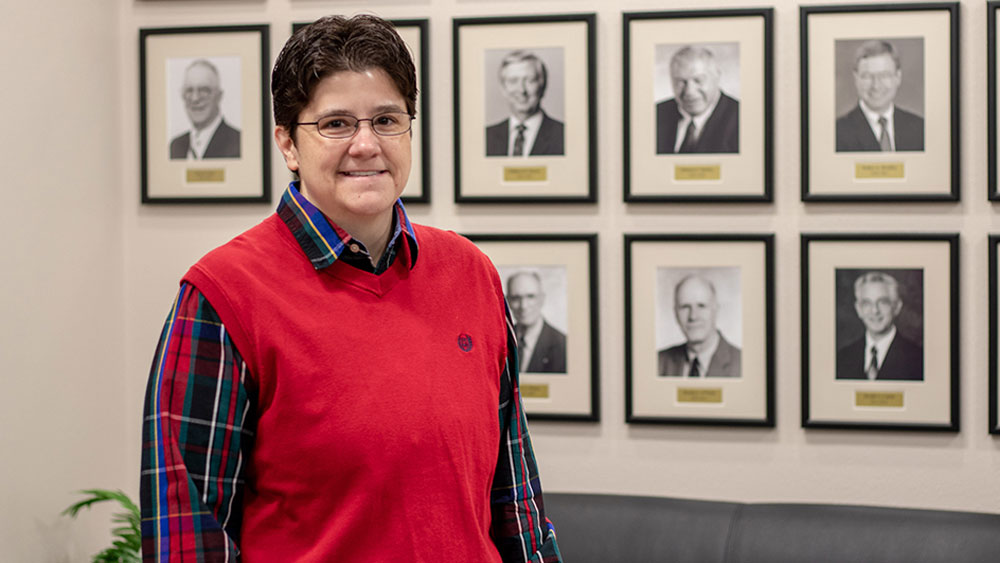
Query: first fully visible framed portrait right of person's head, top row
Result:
<box><xmin>452</xmin><ymin>14</ymin><xmax>597</xmax><ymax>203</ymax></box>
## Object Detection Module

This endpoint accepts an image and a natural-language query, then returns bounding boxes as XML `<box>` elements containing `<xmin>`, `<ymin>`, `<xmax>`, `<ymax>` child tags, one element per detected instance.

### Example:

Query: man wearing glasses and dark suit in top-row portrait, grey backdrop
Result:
<box><xmin>837</xmin><ymin>40</ymin><xmax>924</xmax><ymax>152</ymax></box>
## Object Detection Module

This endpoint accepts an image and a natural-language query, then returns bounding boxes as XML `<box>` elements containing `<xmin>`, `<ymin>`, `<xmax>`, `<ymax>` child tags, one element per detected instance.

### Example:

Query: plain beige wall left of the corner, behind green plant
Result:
<box><xmin>0</xmin><ymin>0</ymin><xmax>125</xmax><ymax>562</ymax></box>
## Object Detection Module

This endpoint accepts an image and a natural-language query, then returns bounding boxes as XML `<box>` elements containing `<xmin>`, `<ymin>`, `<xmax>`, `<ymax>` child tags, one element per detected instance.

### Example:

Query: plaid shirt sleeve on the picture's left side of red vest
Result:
<box><xmin>139</xmin><ymin>283</ymin><xmax>255</xmax><ymax>563</ymax></box>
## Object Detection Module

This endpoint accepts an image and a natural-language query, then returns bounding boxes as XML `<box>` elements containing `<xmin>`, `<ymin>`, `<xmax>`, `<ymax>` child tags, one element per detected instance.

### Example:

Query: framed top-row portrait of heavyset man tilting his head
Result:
<box><xmin>623</xmin><ymin>8</ymin><xmax>774</xmax><ymax>202</ymax></box>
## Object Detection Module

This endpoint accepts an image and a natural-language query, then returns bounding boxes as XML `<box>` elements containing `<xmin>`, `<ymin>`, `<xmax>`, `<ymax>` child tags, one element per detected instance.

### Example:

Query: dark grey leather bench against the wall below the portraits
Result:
<box><xmin>544</xmin><ymin>492</ymin><xmax>1000</xmax><ymax>563</ymax></box>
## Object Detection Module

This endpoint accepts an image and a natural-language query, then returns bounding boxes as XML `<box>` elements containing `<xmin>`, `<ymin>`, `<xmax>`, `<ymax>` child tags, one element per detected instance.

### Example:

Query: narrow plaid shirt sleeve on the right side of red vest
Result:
<box><xmin>490</xmin><ymin>308</ymin><xmax>562</xmax><ymax>563</ymax></box>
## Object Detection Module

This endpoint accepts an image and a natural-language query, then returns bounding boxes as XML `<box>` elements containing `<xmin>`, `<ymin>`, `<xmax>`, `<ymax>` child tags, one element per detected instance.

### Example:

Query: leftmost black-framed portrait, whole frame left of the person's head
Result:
<box><xmin>139</xmin><ymin>25</ymin><xmax>272</xmax><ymax>203</ymax></box>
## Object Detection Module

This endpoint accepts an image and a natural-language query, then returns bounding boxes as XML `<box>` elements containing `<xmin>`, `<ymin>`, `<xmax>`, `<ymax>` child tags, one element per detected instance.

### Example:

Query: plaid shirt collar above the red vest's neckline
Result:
<box><xmin>277</xmin><ymin>180</ymin><xmax>417</xmax><ymax>270</ymax></box>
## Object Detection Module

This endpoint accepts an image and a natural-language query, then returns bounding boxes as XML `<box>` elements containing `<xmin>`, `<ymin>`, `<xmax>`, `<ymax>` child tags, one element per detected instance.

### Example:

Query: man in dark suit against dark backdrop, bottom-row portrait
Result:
<box><xmin>837</xmin><ymin>272</ymin><xmax>924</xmax><ymax>381</ymax></box>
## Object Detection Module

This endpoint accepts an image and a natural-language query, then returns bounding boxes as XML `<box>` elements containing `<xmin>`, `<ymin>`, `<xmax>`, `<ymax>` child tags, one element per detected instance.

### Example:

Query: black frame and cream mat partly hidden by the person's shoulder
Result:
<box><xmin>465</xmin><ymin>233</ymin><xmax>601</xmax><ymax>422</ymax></box>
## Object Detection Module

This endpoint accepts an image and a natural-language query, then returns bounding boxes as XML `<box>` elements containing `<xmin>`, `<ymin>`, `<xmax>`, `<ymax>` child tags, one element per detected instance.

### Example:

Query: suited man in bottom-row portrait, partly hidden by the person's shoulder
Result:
<box><xmin>507</xmin><ymin>270</ymin><xmax>566</xmax><ymax>373</ymax></box>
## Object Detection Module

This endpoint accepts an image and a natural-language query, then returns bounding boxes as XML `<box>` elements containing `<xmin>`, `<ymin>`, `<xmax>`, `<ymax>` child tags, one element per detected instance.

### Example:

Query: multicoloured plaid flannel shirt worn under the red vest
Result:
<box><xmin>140</xmin><ymin>183</ymin><xmax>561</xmax><ymax>563</ymax></box>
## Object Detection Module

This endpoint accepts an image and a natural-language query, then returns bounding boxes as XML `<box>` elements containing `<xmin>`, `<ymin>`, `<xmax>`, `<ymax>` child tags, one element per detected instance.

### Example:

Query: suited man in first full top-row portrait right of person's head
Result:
<box><xmin>486</xmin><ymin>51</ymin><xmax>564</xmax><ymax>156</ymax></box>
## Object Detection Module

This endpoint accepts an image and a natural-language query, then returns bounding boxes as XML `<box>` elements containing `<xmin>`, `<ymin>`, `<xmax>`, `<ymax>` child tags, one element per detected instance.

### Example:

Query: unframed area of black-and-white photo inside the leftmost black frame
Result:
<box><xmin>167</xmin><ymin>57</ymin><xmax>242</xmax><ymax>160</ymax></box>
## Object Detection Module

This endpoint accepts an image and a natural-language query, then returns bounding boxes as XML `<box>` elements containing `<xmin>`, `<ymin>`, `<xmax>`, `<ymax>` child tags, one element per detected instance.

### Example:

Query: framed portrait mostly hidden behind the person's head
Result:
<box><xmin>292</xmin><ymin>19</ymin><xmax>431</xmax><ymax>203</ymax></box>
